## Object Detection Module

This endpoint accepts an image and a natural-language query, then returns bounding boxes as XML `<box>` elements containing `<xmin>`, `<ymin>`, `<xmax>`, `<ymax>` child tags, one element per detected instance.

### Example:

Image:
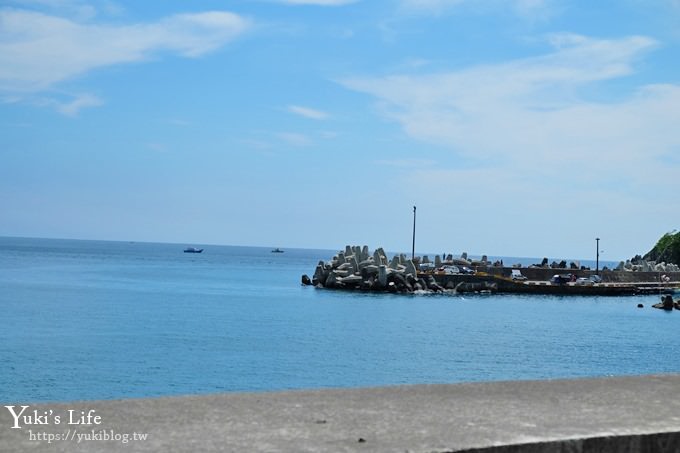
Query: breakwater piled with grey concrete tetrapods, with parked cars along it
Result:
<box><xmin>302</xmin><ymin>245</ymin><xmax>680</xmax><ymax>296</ymax></box>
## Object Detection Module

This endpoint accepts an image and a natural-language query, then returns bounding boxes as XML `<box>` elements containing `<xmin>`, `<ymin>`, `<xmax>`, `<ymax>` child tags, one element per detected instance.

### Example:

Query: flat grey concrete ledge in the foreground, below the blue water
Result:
<box><xmin>0</xmin><ymin>375</ymin><xmax>680</xmax><ymax>453</ymax></box>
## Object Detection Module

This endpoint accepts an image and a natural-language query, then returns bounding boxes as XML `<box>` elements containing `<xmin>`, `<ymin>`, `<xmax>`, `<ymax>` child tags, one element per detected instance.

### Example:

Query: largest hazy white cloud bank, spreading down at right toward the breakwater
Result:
<box><xmin>342</xmin><ymin>35</ymin><xmax>680</xmax><ymax>259</ymax></box>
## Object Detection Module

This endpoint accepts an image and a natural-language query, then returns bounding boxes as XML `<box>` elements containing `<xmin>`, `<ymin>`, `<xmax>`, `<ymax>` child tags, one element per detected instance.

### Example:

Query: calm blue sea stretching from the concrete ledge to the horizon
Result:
<box><xmin>0</xmin><ymin>238</ymin><xmax>680</xmax><ymax>403</ymax></box>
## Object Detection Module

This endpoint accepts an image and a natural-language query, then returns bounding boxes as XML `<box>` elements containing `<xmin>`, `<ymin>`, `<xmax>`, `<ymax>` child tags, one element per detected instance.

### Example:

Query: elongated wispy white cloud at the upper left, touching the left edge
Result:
<box><xmin>0</xmin><ymin>9</ymin><xmax>249</xmax><ymax>92</ymax></box>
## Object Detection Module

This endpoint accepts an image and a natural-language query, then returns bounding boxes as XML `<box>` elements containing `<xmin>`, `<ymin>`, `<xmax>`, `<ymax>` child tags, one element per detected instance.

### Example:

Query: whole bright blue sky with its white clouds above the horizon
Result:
<box><xmin>0</xmin><ymin>0</ymin><xmax>680</xmax><ymax>261</ymax></box>
